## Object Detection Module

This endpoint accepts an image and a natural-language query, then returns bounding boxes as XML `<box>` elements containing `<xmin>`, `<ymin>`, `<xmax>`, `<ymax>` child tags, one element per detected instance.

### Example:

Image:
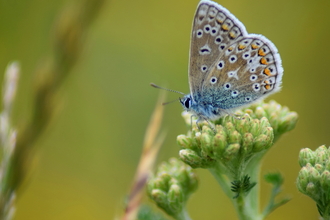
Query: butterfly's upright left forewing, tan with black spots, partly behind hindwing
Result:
<box><xmin>189</xmin><ymin>0</ymin><xmax>246</xmax><ymax>101</ymax></box>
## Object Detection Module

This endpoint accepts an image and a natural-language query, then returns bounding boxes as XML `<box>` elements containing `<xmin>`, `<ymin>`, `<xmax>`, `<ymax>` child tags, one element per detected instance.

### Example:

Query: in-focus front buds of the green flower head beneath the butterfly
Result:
<box><xmin>177</xmin><ymin>114</ymin><xmax>274</xmax><ymax>174</ymax></box>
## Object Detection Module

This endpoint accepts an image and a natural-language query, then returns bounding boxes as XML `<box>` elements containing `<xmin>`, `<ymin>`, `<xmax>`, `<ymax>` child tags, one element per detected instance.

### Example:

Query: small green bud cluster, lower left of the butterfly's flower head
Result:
<box><xmin>147</xmin><ymin>158</ymin><xmax>198</xmax><ymax>217</ymax></box>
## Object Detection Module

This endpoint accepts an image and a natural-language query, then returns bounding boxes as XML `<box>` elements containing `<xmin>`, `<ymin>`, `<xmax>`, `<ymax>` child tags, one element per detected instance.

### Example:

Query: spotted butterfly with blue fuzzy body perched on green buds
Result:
<box><xmin>152</xmin><ymin>0</ymin><xmax>283</xmax><ymax>130</ymax></box>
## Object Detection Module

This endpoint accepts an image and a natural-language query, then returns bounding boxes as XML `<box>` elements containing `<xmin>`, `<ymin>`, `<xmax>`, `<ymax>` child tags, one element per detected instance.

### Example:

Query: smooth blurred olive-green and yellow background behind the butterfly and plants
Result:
<box><xmin>0</xmin><ymin>0</ymin><xmax>330</xmax><ymax>220</ymax></box>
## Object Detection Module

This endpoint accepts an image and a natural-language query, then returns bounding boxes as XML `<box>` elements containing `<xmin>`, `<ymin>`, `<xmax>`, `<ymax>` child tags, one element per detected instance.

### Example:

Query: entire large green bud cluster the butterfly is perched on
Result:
<box><xmin>177</xmin><ymin>101</ymin><xmax>297</xmax><ymax>176</ymax></box>
